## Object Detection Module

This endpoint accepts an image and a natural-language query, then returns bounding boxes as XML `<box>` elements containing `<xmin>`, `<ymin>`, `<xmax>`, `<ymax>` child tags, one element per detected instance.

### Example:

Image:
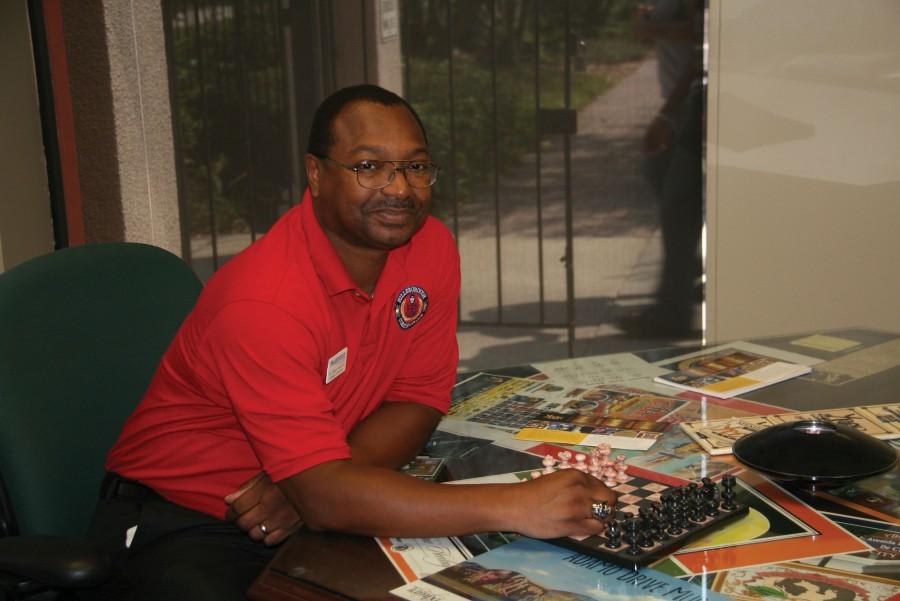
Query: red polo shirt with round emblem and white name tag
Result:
<box><xmin>106</xmin><ymin>192</ymin><xmax>459</xmax><ymax>517</ymax></box>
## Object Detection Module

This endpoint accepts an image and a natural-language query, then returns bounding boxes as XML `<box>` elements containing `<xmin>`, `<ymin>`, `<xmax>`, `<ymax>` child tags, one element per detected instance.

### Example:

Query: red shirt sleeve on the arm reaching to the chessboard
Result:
<box><xmin>201</xmin><ymin>301</ymin><xmax>350</xmax><ymax>481</ymax></box>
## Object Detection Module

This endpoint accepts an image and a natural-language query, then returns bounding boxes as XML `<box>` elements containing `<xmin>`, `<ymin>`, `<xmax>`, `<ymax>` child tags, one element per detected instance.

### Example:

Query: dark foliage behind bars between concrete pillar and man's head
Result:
<box><xmin>167</xmin><ymin>0</ymin><xmax>291</xmax><ymax>235</ymax></box>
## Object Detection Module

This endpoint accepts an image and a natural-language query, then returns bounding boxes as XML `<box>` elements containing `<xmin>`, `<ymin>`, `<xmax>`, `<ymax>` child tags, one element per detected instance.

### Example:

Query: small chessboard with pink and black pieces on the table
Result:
<box><xmin>531</xmin><ymin>445</ymin><xmax>749</xmax><ymax>569</ymax></box>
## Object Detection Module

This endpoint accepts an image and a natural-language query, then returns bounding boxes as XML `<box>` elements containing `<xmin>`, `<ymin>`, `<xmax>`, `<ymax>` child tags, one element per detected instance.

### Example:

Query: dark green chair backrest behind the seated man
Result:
<box><xmin>0</xmin><ymin>243</ymin><xmax>202</xmax><ymax>536</ymax></box>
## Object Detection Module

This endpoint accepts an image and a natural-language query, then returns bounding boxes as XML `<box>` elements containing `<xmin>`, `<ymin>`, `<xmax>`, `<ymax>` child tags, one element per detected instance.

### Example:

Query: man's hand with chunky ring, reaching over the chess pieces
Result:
<box><xmin>509</xmin><ymin>469</ymin><xmax>616</xmax><ymax>538</ymax></box>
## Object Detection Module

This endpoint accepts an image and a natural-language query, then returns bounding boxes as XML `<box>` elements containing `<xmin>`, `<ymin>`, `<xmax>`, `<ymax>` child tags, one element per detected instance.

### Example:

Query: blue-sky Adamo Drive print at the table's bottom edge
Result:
<box><xmin>391</xmin><ymin>538</ymin><xmax>728</xmax><ymax>601</ymax></box>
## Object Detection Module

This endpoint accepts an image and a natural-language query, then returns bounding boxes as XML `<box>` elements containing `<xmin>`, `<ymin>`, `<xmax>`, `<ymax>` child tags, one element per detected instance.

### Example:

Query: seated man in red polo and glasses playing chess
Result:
<box><xmin>94</xmin><ymin>85</ymin><xmax>615</xmax><ymax>599</ymax></box>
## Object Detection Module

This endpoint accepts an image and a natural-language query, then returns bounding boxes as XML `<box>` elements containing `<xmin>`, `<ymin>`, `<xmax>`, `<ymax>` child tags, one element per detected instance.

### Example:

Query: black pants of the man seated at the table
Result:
<box><xmin>83</xmin><ymin>477</ymin><xmax>275</xmax><ymax>601</ymax></box>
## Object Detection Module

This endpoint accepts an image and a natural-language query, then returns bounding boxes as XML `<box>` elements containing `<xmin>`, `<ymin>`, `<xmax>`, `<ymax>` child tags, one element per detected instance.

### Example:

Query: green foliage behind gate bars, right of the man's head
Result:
<box><xmin>402</xmin><ymin>0</ymin><xmax>648</xmax><ymax>218</ymax></box>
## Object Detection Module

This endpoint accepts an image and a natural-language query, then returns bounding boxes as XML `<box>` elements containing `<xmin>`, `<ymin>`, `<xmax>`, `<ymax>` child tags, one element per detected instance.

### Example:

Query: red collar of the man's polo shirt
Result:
<box><xmin>300</xmin><ymin>188</ymin><xmax>415</xmax><ymax>300</ymax></box>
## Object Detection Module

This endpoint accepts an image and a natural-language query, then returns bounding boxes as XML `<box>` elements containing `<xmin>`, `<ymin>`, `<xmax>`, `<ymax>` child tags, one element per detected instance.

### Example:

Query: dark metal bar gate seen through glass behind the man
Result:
<box><xmin>163</xmin><ymin>0</ymin><xmax>676</xmax><ymax>356</ymax></box>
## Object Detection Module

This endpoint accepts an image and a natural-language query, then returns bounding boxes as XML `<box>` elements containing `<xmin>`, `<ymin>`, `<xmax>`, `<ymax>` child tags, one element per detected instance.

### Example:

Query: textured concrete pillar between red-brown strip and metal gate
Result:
<box><xmin>62</xmin><ymin>0</ymin><xmax>181</xmax><ymax>254</ymax></box>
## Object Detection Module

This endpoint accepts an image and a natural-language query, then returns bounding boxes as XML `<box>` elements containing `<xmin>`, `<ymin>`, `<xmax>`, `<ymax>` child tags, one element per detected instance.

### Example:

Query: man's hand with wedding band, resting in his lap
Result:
<box><xmin>225</xmin><ymin>472</ymin><xmax>303</xmax><ymax>546</ymax></box>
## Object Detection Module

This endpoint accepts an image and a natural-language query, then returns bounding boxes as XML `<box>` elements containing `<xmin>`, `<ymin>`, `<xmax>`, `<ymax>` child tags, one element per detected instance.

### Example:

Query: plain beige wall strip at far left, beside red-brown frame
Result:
<box><xmin>0</xmin><ymin>1</ymin><xmax>53</xmax><ymax>272</ymax></box>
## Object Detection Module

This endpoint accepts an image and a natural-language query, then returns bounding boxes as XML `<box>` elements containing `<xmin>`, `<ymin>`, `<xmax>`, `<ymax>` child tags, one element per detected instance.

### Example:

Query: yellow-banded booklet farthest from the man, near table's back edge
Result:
<box><xmin>653</xmin><ymin>348</ymin><xmax>812</xmax><ymax>399</ymax></box>
